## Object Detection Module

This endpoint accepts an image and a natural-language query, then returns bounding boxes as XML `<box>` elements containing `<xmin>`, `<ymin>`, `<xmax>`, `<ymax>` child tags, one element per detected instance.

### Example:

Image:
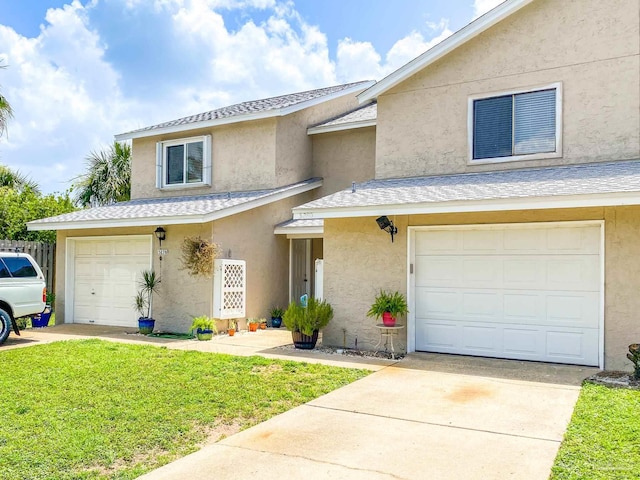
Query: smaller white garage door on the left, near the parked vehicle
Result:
<box><xmin>72</xmin><ymin>236</ymin><xmax>152</xmax><ymax>327</ymax></box>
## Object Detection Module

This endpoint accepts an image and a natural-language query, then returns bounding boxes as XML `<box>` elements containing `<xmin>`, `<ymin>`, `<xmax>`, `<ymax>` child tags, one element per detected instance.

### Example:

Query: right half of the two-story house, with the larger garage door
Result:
<box><xmin>294</xmin><ymin>0</ymin><xmax>640</xmax><ymax>370</ymax></box>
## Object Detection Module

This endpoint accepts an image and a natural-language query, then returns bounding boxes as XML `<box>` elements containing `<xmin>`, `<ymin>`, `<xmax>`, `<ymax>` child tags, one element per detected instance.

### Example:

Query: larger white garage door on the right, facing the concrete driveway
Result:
<box><xmin>414</xmin><ymin>223</ymin><xmax>602</xmax><ymax>365</ymax></box>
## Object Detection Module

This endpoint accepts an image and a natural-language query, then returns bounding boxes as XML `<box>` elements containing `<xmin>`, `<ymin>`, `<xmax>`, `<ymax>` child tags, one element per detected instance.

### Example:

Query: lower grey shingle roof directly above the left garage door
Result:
<box><xmin>28</xmin><ymin>178</ymin><xmax>320</xmax><ymax>230</ymax></box>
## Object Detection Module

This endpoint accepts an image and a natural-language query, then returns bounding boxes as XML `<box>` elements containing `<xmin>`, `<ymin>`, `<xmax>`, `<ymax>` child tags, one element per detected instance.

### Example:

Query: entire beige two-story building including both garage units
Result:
<box><xmin>30</xmin><ymin>0</ymin><xmax>640</xmax><ymax>370</ymax></box>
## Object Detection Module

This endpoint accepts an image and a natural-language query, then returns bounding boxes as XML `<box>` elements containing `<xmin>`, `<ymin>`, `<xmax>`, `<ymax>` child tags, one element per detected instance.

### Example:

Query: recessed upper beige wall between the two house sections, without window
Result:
<box><xmin>312</xmin><ymin>127</ymin><xmax>376</xmax><ymax>197</ymax></box>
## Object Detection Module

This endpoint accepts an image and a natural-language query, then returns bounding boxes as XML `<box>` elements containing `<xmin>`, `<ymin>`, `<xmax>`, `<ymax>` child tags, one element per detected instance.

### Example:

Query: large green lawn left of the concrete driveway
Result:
<box><xmin>0</xmin><ymin>340</ymin><xmax>369</xmax><ymax>480</ymax></box>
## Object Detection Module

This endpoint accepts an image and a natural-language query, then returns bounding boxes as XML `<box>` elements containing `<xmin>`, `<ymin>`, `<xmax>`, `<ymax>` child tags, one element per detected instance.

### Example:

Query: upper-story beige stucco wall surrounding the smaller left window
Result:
<box><xmin>131</xmin><ymin>89</ymin><xmax>364</xmax><ymax>199</ymax></box>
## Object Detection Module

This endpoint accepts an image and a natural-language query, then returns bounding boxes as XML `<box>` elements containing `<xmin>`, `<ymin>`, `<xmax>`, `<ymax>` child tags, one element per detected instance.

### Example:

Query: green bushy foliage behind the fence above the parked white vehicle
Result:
<box><xmin>0</xmin><ymin>186</ymin><xmax>75</xmax><ymax>243</ymax></box>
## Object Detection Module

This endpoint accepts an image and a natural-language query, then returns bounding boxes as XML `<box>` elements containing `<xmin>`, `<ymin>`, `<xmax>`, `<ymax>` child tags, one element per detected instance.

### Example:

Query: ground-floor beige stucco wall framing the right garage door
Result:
<box><xmin>323</xmin><ymin>207</ymin><xmax>640</xmax><ymax>370</ymax></box>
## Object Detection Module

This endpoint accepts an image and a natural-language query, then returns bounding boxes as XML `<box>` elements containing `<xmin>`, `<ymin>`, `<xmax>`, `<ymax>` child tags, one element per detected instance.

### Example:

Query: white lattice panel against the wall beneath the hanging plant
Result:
<box><xmin>213</xmin><ymin>259</ymin><xmax>247</xmax><ymax>319</ymax></box>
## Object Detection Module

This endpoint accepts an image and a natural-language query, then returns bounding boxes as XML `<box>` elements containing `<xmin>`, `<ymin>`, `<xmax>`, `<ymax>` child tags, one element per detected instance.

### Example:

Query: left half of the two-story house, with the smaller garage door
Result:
<box><xmin>29</xmin><ymin>82</ymin><xmax>374</xmax><ymax>332</ymax></box>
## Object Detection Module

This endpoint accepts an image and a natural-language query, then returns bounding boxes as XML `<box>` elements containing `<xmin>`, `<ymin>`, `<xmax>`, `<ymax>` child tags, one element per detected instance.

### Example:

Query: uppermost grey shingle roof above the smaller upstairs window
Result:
<box><xmin>118</xmin><ymin>80</ymin><xmax>373</xmax><ymax>136</ymax></box>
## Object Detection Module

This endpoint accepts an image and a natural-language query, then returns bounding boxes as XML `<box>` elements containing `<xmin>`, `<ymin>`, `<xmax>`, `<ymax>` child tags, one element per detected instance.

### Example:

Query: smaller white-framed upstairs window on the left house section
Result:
<box><xmin>156</xmin><ymin>135</ymin><xmax>211</xmax><ymax>188</ymax></box>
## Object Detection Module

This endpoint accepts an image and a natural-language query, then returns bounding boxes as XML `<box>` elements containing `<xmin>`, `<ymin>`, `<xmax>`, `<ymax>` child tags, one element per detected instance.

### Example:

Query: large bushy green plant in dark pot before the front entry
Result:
<box><xmin>282</xmin><ymin>298</ymin><xmax>333</xmax><ymax>350</ymax></box>
